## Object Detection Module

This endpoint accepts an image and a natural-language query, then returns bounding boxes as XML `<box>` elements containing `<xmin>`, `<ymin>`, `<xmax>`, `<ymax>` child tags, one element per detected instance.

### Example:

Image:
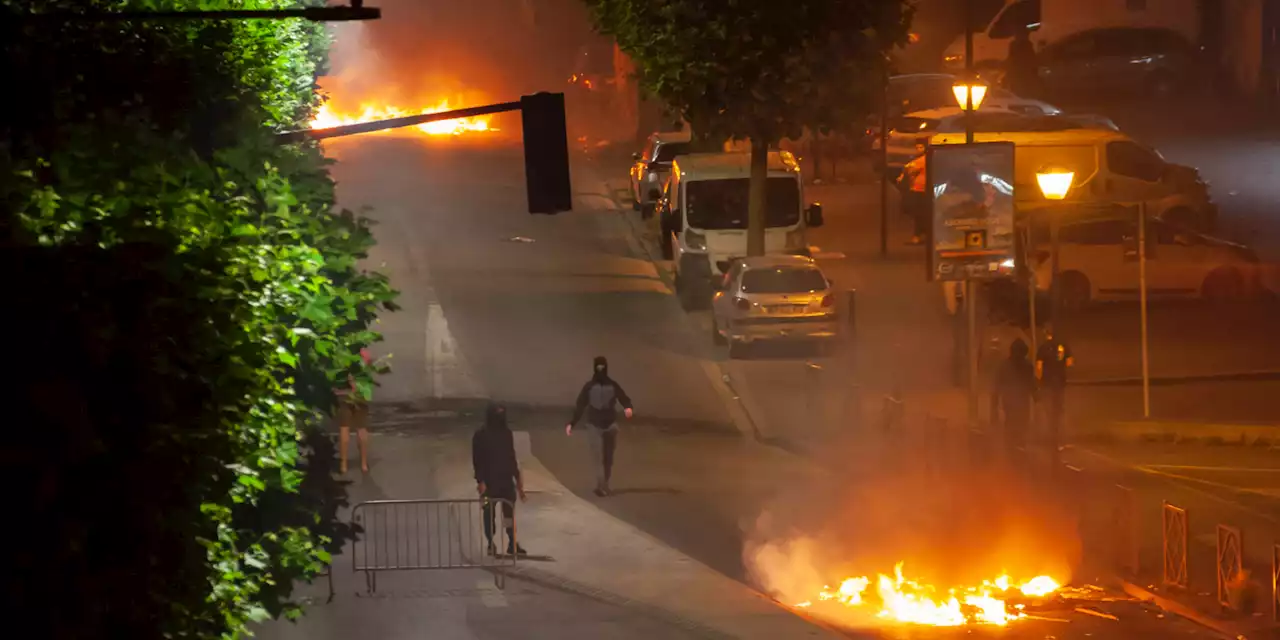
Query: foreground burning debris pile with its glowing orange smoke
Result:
<box><xmin>744</xmin><ymin>444</ymin><xmax>1080</xmax><ymax>628</ymax></box>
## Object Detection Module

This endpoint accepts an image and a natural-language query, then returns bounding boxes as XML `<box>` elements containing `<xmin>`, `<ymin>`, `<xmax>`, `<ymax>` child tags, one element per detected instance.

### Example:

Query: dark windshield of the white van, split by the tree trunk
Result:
<box><xmin>685</xmin><ymin>178</ymin><xmax>800</xmax><ymax>229</ymax></box>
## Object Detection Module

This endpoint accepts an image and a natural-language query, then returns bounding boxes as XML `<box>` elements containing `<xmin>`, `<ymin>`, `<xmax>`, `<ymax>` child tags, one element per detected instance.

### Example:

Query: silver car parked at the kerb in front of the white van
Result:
<box><xmin>712</xmin><ymin>255</ymin><xmax>840</xmax><ymax>357</ymax></box>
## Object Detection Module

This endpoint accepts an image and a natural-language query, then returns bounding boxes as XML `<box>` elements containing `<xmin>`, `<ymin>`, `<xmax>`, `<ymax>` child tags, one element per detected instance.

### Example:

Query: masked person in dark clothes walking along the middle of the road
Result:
<box><xmin>564</xmin><ymin>356</ymin><xmax>631</xmax><ymax>498</ymax></box>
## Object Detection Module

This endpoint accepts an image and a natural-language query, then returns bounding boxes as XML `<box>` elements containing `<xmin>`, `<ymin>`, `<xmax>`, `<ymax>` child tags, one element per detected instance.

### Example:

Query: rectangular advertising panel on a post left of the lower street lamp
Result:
<box><xmin>925</xmin><ymin>142</ymin><xmax>1015</xmax><ymax>280</ymax></box>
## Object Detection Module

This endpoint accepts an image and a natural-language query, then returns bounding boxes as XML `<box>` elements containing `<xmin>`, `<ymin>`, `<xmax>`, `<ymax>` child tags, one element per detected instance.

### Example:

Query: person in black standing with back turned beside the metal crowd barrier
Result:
<box><xmin>471</xmin><ymin>403</ymin><xmax>525</xmax><ymax>556</ymax></box>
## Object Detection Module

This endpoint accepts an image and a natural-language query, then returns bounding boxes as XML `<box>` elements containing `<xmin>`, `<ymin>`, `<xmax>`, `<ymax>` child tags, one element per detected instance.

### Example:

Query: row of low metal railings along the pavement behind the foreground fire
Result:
<box><xmin>885</xmin><ymin>398</ymin><xmax>1280</xmax><ymax>622</ymax></box>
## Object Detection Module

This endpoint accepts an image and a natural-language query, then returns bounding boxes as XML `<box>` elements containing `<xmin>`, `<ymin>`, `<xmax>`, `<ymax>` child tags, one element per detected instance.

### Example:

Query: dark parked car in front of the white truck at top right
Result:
<box><xmin>1039</xmin><ymin>27</ymin><xmax>1203</xmax><ymax>99</ymax></box>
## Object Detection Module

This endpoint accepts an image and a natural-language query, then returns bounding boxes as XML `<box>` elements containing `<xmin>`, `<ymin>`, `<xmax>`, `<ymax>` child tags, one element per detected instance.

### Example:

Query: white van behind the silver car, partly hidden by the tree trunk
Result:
<box><xmin>658</xmin><ymin>151</ymin><xmax>822</xmax><ymax>308</ymax></box>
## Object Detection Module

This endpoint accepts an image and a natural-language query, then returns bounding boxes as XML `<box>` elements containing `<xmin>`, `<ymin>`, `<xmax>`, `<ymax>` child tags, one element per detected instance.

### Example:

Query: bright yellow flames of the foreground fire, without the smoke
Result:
<box><xmin>796</xmin><ymin>562</ymin><xmax>1061</xmax><ymax>627</ymax></box>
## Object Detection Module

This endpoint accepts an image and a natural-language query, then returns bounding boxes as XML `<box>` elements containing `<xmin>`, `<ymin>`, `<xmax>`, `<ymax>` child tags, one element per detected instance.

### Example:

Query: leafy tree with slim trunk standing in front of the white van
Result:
<box><xmin>585</xmin><ymin>0</ymin><xmax>913</xmax><ymax>256</ymax></box>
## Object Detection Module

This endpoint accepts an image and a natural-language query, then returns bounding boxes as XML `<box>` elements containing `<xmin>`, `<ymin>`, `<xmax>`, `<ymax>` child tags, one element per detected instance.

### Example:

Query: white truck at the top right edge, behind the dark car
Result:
<box><xmin>942</xmin><ymin>0</ymin><xmax>1201</xmax><ymax>70</ymax></box>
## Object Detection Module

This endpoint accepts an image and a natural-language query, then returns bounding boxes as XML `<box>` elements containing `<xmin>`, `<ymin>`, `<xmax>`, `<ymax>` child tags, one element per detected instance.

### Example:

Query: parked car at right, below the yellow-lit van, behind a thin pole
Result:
<box><xmin>1032</xmin><ymin>215</ymin><xmax>1267</xmax><ymax>308</ymax></box>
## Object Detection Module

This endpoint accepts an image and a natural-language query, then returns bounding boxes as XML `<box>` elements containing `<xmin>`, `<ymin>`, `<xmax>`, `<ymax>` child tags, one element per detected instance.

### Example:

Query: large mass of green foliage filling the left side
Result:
<box><xmin>0</xmin><ymin>0</ymin><xmax>394</xmax><ymax>639</ymax></box>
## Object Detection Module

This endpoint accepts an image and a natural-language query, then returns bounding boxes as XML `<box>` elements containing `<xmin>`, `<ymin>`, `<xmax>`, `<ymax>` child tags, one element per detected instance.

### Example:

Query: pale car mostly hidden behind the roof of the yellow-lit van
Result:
<box><xmin>872</xmin><ymin>104</ymin><xmax>1120</xmax><ymax>174</ymax></box>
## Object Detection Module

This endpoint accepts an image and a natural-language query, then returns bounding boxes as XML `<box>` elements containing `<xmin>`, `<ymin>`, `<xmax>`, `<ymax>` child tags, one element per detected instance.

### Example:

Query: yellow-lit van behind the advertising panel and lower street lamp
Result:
<box><xmin>929</xmin><ymin>129</ymin><xmax>1217</xmax><ymax>232</ymax></box>
